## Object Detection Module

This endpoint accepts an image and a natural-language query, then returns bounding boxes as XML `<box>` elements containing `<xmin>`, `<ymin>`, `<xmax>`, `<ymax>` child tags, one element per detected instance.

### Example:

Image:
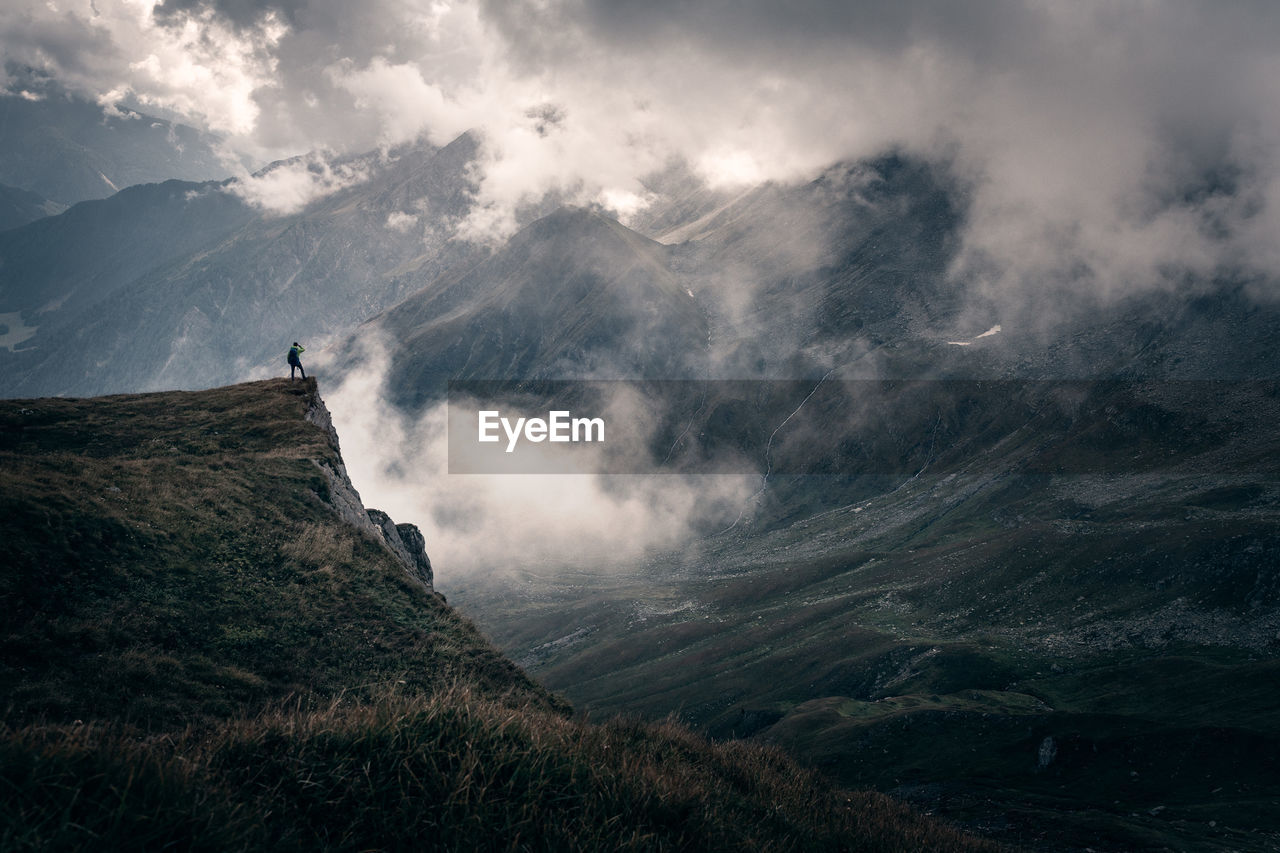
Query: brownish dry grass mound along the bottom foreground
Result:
<box><xmin>0</xmin><ymin>685</ymin><xmax>996</xmax><ymax>853</ymax></box>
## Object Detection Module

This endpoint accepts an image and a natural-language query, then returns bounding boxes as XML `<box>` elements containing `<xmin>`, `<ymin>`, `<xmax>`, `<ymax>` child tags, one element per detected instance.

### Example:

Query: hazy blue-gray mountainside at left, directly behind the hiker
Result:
<box><xmin>0</xmin><ymin>136</ymin><xmax>480</xmax><ymax>396</ymax></box>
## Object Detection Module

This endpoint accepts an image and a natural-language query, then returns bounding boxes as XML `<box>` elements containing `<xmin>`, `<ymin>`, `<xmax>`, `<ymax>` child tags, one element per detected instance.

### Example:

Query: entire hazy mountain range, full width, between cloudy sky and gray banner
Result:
<box><xmin>0</xmin><ymin>128</ymin><xmax>1280</xmax><ymax>399</ymax></box>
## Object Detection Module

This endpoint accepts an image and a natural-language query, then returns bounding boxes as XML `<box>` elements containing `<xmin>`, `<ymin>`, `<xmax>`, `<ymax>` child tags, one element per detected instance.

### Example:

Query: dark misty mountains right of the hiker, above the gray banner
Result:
<box><xmin>355</xmin><ymin>156</ymin><xmax>1280</xmax><ymax>422</ymax></box>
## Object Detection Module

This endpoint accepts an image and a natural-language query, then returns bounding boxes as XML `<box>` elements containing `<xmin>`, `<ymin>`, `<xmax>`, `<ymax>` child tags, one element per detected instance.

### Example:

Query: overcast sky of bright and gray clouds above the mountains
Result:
<box><xmin>0</xmin><ymin>0</ymin><xmax>1280</xmax><ymax>292</ymax></box>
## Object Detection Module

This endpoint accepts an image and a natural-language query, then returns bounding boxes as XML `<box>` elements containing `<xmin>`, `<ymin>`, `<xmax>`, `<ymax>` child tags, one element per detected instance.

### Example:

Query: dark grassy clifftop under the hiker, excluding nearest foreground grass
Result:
<box><xmin>0</xmin><ymin>380</ymin><xmax>558</xmax><ymax>727</ymax></box>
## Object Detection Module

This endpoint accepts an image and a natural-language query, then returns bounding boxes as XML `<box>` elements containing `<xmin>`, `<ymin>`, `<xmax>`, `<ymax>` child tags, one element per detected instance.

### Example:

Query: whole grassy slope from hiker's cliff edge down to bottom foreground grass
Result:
<box><xmin>0</xmin><ymin>380</ymin><xmax>993</xmax><ymax>852</ymax></box>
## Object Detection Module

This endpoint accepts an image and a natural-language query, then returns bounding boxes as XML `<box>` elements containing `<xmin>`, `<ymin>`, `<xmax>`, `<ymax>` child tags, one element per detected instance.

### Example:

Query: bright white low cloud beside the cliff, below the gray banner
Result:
<box><xmin>315</xmin><ymin>339</ymin><xmax>759</xmax><ymax>578</ymax></box>
